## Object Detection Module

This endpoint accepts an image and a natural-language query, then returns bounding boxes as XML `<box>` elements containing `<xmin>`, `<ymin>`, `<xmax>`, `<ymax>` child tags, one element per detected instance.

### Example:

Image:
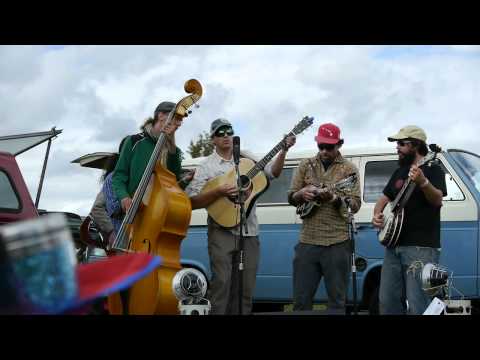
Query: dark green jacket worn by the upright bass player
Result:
<box><xmin>112</xmin><ymin>133</ymin><xmax>182</xmax><ymax>201</ymax></box>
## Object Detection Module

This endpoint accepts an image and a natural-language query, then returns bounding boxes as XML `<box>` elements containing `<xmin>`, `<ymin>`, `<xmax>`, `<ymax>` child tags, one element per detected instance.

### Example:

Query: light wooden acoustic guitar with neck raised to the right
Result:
<box><xmin>200</xmin><ymin>116</ymin><xmax>313</xmax><ymax>229</ymax></box>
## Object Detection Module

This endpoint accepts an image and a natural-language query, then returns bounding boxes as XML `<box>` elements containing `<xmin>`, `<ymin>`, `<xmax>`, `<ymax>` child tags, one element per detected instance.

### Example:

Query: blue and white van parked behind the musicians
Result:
<box><xmin>181</xmin><ymin>146</ymin><xmax>480</xmax><ymax>313</ymax></box>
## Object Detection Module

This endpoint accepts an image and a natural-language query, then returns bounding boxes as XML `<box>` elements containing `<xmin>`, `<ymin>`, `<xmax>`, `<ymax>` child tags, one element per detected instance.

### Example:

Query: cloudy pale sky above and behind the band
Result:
<box><xmin>0</xmin><ymin>45</ymin><xmax>480</xmax><ymax>215</ymax></box>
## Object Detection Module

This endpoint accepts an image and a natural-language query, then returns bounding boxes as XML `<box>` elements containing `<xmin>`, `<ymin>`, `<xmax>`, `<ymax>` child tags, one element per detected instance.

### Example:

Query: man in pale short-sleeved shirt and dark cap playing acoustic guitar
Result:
<box><xmin>186</xmin><ymin>119</ymin><xmax>295</xmax><ymax>315</ymax></box>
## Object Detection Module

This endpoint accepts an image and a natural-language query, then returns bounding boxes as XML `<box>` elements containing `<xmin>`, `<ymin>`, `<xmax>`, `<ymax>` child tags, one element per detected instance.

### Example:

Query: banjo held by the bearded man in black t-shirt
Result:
<box><xmin>378</xmin><ymin>144</ymin><xmax>442</xmax><ymax>248</ymax></box>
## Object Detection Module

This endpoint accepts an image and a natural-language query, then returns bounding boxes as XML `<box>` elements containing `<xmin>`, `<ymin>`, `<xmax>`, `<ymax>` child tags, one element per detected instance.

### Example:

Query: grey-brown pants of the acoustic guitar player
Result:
<box><xmin>207</xmin><ymin>223</ymin><xmax>260</xmax><ymax>315</ymax></box>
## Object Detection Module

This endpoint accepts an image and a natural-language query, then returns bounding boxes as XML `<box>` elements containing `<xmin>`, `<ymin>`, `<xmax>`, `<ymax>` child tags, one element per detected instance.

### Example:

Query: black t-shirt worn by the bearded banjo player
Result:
<box><xmin>383</xmin><ymin>164</ymin><xmax>447</xmax><ymax>248</ymax></box>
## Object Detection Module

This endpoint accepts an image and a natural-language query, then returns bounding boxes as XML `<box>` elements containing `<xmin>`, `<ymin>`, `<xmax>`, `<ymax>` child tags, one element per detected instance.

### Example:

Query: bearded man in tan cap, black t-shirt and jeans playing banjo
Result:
<box><xmin>372</xmin><ymin>126</ymin><xmax>447</xmax><ymax>315</ymax></box>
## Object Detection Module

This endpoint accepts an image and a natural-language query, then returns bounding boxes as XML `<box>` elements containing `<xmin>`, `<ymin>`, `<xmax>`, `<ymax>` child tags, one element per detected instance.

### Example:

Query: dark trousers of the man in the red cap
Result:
<box><xmin>293</xmin><ymin>241</ymin><xmax>352</xmax><ymax>310</ymax></box>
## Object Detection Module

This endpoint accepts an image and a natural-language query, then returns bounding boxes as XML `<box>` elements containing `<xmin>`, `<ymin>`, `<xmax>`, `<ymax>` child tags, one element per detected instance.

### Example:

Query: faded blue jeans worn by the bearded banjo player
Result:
<box><xmin>379</xmin><ymin>246</ymin><xmax>440</xmax><ymax>315</ymax></box>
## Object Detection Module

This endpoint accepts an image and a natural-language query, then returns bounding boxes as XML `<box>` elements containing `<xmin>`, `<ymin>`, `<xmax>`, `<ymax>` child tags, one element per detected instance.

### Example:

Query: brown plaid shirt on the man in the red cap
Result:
<box><xmin>288</xmin><ymin>153</ymin><xmax>361</xmax><ymax>246</ymax></box>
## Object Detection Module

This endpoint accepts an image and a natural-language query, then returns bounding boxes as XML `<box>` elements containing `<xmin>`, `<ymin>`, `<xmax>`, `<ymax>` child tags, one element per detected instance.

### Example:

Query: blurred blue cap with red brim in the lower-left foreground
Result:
<box><xmin>0</xmin><ymin>214</ymin><xmax>161</xmax><ymax>314</ymax></box>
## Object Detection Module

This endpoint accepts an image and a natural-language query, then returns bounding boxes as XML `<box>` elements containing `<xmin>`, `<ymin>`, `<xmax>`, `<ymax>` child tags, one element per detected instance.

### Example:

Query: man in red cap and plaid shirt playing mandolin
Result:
<box><xmin>288</xmin><ymin>123</ymin><xmax>361</xmax><ymax>311</ymax></box>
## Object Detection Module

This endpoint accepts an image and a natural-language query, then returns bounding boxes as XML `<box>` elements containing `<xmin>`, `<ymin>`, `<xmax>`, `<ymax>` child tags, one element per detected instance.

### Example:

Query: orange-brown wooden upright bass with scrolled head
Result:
<box><xmin>108</xmin><ymin>79</ymin><xmax>202</xmax><ymax>315</ymax></box>
